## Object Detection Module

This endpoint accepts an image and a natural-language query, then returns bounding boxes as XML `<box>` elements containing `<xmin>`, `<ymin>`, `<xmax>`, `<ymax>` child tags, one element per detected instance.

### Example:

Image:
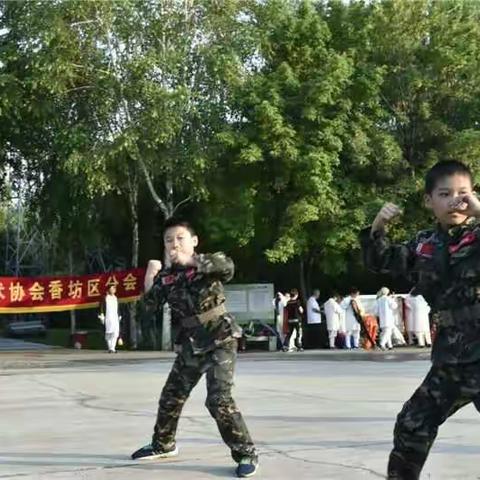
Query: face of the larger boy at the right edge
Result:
<box><xmin>425</xmin><ymin>173</ymin><xmax>472</xmax><ymax>228</ymax></box>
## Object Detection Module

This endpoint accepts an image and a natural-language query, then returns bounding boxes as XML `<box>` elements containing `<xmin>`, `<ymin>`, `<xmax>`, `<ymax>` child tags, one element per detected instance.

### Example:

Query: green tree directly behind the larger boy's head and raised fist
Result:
<box><xmin>319</xmin><ymin>0</ymin><xmax>480</xmax><ymax>288</ymax></box>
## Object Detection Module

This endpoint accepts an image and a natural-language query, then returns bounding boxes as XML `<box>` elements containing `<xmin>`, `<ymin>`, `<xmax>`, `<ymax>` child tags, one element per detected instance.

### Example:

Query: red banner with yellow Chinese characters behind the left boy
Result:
<box><xmin>0</xmin><ymin>268</ymin><xmax>145</xmax><ymax>313</ymax></box>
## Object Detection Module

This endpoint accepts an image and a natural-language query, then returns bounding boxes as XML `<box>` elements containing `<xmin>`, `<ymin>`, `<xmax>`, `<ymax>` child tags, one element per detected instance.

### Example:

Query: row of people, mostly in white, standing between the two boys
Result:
<box><xmin>274</xmin><ymin>287</ymin><xmax>432</xmax><ymax>352</ymax></box>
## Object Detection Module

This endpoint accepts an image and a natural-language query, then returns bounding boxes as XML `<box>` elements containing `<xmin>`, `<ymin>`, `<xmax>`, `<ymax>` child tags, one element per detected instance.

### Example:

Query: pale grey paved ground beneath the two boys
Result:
<box><xmin>0</xmin><ymin>351</ymin><xmax>480</xmax><ymax>480</ymax></box>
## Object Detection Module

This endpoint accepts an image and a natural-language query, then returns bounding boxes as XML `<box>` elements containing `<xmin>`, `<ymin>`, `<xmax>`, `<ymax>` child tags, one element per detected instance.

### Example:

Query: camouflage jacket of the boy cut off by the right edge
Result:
<box><xmin>360</xmin><ymin>219</ymin><xmax>480</xmax><ymax>364</ymax></box>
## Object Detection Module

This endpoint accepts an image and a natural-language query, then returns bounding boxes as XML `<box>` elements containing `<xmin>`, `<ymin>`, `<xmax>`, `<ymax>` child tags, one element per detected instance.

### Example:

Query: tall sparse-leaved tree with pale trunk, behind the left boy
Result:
<box><xmin>2</xmin><ymin>1</ymin><xmax>258</xmax><ymax>344</ymax></box>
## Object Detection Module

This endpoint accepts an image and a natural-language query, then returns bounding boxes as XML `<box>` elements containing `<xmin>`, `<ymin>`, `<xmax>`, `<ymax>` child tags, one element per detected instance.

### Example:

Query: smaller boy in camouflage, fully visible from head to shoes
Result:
<box><xmin>132</xmin><ymin>219</ymin><xmax>257</xmax><ymax>477</ymax></box>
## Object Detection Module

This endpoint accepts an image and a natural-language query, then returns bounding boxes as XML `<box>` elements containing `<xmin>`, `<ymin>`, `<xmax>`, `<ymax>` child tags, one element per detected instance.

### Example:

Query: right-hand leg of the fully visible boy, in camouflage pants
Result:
<box><xmin>206</xmin><ymin>342</ymin><xmax>258</xmax><ymax>477</ymax></box>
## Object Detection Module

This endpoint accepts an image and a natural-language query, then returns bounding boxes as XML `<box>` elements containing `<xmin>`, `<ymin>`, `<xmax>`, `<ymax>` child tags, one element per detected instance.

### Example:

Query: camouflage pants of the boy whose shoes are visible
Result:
<box><xmin>152</xmin><ymin>340</ymin><xmax>257</xmax><ymax>462</ymax></box>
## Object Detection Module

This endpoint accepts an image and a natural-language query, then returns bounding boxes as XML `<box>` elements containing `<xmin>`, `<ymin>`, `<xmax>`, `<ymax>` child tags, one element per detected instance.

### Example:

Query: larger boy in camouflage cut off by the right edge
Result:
<box><xmin>361</xmin><ymin>161</ymin><xmax>480</xmax><ymax>480</ymax></box>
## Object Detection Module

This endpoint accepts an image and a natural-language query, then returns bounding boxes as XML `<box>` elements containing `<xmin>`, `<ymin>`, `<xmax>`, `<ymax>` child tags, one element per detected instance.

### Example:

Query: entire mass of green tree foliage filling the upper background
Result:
<box><xmin>0</xmin><ymin>0</ymin><xmax>480</xmax><ymax>292</ymax></box>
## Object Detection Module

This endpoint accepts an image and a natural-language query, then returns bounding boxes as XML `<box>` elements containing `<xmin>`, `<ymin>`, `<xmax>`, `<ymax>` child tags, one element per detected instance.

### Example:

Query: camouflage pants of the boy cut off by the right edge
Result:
<box><xmin>388</xmin><ymin>362</ymin><xmax>480</xmax><ymax>480</ymax></box>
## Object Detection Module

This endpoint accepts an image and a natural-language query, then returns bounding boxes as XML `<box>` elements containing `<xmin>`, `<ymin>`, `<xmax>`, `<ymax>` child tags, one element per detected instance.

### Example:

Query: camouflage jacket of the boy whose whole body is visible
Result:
<box><xmin>143</xmin><ymin>252</ymin><xmax>242</xmax><ymax>354</ymax></box>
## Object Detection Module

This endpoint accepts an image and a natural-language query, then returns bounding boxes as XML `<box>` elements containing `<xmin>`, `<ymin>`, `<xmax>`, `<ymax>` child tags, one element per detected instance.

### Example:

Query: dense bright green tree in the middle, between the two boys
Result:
<box><xmin>208</xmin><ymin>1</ymin><xmax>353</xmax><ymax>294</ymax></box>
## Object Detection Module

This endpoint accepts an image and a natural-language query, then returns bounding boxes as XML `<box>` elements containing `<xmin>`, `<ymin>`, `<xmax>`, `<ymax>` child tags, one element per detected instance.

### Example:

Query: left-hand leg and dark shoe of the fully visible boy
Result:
<box><xmin>132</xmin><ymin>355</ymin><xmax>202</xmax><ymax>460</ymax></box>
